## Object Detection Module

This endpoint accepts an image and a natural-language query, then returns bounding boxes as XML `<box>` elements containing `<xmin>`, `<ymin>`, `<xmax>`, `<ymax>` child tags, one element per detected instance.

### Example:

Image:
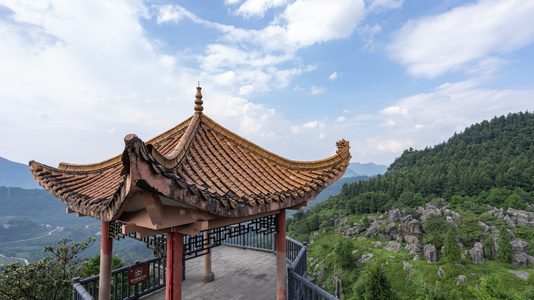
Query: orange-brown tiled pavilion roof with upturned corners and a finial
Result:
<box><xmin>29</xmin><ymin>88</ymin><xmax>351</xmax><ymax>221</ymax></box>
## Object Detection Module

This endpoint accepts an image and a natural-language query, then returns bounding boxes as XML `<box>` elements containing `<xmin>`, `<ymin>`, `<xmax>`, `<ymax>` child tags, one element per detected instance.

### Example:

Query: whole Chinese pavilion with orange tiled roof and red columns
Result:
<box><xmin>29</xmin><ymin>87</ymin><xmax>351</xmax><ymax>299</ymax></box>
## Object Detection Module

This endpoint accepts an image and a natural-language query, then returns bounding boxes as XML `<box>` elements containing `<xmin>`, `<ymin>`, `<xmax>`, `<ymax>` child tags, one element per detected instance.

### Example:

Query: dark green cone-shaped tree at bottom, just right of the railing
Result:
<box><xmin>352</xmin><ymin>262</ymin><xmax>397</xmax><ymax>300</ymax></box>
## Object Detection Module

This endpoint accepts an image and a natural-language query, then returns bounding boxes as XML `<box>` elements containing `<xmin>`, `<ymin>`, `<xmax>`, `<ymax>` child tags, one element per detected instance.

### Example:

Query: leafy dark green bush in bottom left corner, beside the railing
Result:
<box><xmin>0</xmin><ymin>238</ymin><xmax>95</xmax><ymax>300</ymax></box>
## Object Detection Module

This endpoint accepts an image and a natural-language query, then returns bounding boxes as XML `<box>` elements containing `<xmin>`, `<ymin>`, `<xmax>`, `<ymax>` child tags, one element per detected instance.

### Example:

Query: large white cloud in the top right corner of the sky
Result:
<box><xmin>388</xmin><ymin>0</ymin><xmax>534</xmax><ymax>78</ymax></box>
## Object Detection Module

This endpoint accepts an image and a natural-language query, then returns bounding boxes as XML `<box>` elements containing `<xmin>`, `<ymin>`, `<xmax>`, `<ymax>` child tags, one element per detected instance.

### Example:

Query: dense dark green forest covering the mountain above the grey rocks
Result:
<box><xmin>335</xmin><ymin>112</ymin><xmax>534</xmax><ymax>213</ymax></box>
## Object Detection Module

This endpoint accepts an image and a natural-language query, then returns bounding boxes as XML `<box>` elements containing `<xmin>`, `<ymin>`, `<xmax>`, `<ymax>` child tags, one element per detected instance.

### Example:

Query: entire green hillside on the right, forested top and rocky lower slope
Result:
<box><xmin>287</xmin><ymin>112</ymin><xmax>534</xmax><ymax>299</ymax></box>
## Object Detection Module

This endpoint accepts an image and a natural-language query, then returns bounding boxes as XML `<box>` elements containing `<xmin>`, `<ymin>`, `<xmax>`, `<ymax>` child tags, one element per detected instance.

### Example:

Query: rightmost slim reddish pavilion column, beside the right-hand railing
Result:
<box><xmin>276</xmin><ymin>209</ymin><xmax>287</xmax><ymax>300</ymax></box>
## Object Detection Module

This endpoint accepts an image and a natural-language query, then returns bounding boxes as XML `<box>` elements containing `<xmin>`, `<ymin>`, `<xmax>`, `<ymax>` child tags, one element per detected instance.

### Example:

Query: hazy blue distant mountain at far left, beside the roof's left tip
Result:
<box><xmin>0</xmin><ymin>157</ymin><xmax>41</xmax><ymax>189</ymax></box>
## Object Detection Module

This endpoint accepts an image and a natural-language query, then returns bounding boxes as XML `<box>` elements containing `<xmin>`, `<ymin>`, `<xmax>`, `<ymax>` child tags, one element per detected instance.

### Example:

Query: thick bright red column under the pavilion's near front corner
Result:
<box><xmin>165</xmin><ymin>231</ymin><xmax>184</xmax><ymax>300</ymax></box>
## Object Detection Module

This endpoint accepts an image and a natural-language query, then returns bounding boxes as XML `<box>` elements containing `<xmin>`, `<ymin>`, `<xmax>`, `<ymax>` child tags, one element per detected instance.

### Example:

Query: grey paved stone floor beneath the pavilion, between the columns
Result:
<box><xmin>141</xmin><ymin>246</ymin><xmax>276</xmax><ymax>300</ymax></box>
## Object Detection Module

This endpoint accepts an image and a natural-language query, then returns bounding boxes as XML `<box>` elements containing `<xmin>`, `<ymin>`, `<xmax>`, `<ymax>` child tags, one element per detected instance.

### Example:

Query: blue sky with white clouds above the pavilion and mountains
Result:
<box><xmin>0</xmin><ymin>0</ymin><xmax>534</xmax><ymax>166</ymax></box>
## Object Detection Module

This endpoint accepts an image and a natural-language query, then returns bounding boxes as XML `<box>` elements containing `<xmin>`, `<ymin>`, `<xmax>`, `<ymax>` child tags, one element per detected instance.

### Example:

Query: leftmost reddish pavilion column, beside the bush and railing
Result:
<box><xmin>98</xmin><ymin>222</ymin><xmax>113</xmax><ymax>300</ymax></box>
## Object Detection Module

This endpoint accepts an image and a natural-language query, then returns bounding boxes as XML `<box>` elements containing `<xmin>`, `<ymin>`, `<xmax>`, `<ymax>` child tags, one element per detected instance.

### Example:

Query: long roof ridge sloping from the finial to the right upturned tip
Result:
<box><xmin>202</xmin><ymin>114</ymin><xmax>350</xmax><ymax>170</ymax></box>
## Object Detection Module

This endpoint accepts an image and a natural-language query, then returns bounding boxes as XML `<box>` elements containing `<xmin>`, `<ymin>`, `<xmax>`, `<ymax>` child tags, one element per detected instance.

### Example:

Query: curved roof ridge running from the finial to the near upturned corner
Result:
<box><xmin>150</xmin><ymin>113</ymin><xmax>202</xmax><ymax>169</ymax></box>
